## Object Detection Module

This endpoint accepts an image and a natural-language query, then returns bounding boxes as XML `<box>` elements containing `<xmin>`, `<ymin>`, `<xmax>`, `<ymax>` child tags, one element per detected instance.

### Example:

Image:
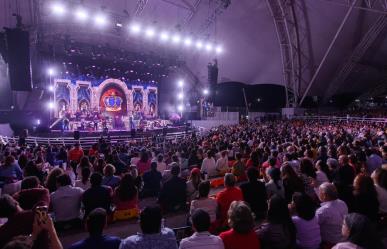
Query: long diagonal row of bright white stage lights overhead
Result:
<box><xmin>50</xmin><ymin>2</ymin><xmax>223</xmax><ymax>54</ymax></box>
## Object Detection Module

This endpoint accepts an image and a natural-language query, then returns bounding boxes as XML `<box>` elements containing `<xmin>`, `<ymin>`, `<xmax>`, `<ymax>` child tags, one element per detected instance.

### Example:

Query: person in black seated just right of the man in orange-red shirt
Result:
<box><xmin>240</xmin><ymin>167</ymin><xmax>267</xmax><ymax>219</ymax></box>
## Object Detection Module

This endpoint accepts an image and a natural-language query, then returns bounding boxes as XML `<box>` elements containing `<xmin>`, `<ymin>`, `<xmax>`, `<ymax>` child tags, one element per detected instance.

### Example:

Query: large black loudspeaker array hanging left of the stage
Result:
<box><xmin>6</xmin><ymin>28</ymin><xmax>32</xmax><ymax>91</ymax></box>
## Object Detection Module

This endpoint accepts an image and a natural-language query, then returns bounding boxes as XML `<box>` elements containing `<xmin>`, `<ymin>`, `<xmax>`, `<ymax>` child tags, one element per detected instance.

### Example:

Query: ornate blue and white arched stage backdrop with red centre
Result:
<box><xmin>54</xmin><ymin>79</ymin><xmax>158</xmax><ymax>118</ymax></box>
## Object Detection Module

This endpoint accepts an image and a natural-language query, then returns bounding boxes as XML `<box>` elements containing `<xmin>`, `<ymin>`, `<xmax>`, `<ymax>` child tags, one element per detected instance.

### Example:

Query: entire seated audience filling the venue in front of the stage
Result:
<box><xmin>0</xmin><ymin>120</ymin><xmax>387</xmax><ymax>249</ymax></box>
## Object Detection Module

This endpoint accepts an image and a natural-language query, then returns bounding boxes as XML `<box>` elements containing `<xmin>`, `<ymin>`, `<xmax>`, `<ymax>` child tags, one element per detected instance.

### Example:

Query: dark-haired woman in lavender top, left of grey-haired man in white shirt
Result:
<box><xmin>291</xmin><ymin>193</ymin><xmax>321</xmax><ymax>249</ymax></box>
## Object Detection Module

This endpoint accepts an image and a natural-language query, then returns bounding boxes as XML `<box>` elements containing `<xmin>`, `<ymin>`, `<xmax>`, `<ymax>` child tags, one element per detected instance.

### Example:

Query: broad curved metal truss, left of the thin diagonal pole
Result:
<box><xmin>266</xmin><ymin>0</ymin><xmax>314</xmax><ymax>107</ymax></box>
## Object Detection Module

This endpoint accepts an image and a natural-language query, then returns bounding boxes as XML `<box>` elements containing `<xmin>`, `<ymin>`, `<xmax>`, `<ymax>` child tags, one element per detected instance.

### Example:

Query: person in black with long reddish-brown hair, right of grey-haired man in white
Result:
<box><xmin>352</xmin><ymin>175</ymin><xmax>379</xmax><ymax>222</ymax></box>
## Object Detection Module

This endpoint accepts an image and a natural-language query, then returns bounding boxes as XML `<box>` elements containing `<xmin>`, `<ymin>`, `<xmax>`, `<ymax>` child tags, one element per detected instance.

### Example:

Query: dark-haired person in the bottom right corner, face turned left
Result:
<box><xmin>332</xmin><ymin>213</ymin><xmax>384</xmax><ymax>249</ymax></box>
